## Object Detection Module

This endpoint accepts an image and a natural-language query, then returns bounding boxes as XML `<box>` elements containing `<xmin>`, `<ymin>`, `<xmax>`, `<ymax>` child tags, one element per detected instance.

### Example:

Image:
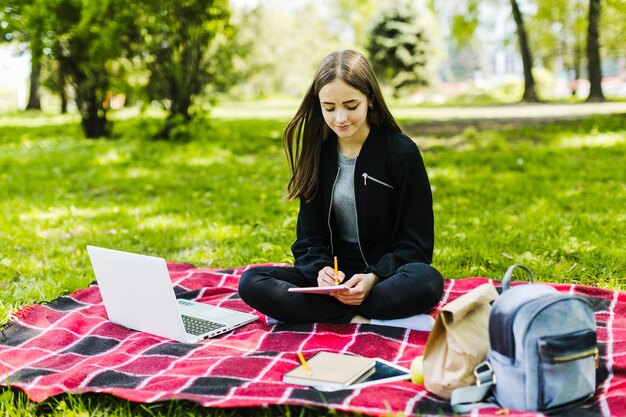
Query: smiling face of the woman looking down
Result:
<box><xmin>319</xmin><ymin>79</ymin><xmax>370</xmax><ymax>144</ymax></box>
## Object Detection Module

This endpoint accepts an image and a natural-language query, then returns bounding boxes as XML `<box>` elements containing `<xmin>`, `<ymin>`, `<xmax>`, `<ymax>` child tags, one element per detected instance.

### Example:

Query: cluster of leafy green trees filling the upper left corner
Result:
<box><xmin>0</xmin><ymin>0</ymin><xmax>234</xmax><ymax>138</ymax></box>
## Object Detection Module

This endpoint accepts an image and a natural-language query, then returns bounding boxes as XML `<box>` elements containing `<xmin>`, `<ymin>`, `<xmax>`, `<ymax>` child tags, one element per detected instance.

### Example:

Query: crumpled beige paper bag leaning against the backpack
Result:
<box><xmin>424</xmin><ymin>284</ymin><xmax>498</xmax><ymax>399</ymax></box>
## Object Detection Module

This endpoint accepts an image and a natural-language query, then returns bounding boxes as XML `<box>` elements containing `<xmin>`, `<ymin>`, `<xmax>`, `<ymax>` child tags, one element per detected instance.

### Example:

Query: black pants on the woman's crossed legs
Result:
<box><xmin>239</xmin><ymin>240</ymin><xmax>443</xmax><ymax>323</ymax></box>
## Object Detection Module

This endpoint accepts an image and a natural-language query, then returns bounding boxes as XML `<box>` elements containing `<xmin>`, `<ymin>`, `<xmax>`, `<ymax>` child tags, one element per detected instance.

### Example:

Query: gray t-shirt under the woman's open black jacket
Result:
<box><xmin>333</xmin><ymin>152</ymin><xmax>358</xmax><ymax>243</ymax></box>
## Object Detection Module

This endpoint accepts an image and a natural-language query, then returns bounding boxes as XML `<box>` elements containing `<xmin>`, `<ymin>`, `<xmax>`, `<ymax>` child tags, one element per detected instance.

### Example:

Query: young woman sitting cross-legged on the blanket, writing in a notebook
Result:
<box><xmin>239</xmin><ymin>50</ymin><xmax>443</xmax><ymax>330</ymax></box>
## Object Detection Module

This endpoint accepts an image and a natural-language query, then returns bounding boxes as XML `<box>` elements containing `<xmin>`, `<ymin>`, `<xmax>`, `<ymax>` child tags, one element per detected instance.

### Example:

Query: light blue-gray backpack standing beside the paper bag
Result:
<box><xmin>450</xmin><ymin>265</ymin><xmax>598</xmax><ymax>412</ymax></box>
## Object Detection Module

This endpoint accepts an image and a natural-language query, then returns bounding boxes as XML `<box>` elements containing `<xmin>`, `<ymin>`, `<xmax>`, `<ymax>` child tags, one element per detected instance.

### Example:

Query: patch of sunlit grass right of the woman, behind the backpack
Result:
<box><xmin>418</xmin><ymin>116</ymin><xmax>626</xmax><ymax>289</ymax></box>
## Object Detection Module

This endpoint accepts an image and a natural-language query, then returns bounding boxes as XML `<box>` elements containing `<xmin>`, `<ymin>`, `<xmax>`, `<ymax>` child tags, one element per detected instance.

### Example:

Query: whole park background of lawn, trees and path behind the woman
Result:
<box><xmin>0</xmin><ymin>0</ymin><xmax>626</xmax><ymax>416</ymax></box>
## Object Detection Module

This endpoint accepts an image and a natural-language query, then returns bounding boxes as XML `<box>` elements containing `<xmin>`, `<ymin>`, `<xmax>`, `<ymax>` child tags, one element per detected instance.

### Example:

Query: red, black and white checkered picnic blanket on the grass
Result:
<box><xmin>0</xmin><ymin>263</ymin><xmax>626</xmax><ymax>416</ymax></box>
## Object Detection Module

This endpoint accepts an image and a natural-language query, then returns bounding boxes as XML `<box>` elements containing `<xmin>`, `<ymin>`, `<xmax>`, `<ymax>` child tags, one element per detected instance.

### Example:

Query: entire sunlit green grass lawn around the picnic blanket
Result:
<box><xmin>0</xmin><ymin>105</ymin><xmax>626</xmax><ymax>417</ymax></box>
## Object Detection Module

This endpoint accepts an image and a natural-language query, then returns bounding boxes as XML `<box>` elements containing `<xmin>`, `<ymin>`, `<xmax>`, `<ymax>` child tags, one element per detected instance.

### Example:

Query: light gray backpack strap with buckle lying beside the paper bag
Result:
<box><xmin>450</xmin><ymin>361</ymin><xmax>500</xmax><ymax>413</ymax></box>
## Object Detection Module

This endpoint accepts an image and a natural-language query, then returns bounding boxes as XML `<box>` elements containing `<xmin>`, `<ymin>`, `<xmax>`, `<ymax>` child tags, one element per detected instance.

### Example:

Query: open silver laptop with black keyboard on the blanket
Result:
<box><xmin>87</xmin><ymin>246</ymin><xmax>257</xmax><ymax>343</ymax></box>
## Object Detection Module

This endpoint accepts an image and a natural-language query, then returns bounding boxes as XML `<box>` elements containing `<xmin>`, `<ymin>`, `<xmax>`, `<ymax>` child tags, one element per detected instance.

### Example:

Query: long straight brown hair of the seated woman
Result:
<box><xmin>283</xmin><ymin>49</ymin><xmax>401</xmax><ymax>201</ymax></box>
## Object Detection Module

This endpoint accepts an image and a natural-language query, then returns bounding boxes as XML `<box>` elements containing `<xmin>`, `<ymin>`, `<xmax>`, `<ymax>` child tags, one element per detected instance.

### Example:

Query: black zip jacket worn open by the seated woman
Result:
<box><xmin>291</xmin><ymin>128</ymin><xmax>434</xmax><ymax>285</ymax></box>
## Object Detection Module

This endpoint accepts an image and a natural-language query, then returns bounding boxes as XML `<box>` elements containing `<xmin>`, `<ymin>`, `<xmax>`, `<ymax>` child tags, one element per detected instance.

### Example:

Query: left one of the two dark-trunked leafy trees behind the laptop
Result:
<box><xmin>33</xmin><ymin>0</ymin><xmax>138</xmax><ymax>138</ymax></box>
